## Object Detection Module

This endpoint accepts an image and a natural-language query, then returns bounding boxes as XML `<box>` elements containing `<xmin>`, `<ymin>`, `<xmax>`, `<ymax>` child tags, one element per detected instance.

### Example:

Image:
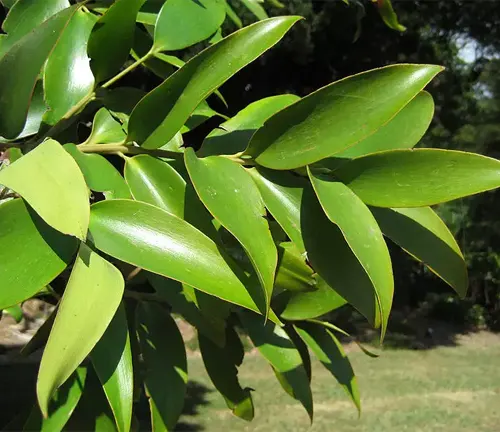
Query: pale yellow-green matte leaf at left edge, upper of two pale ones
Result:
<box><xmin>0</xmin><ymin>140</ymin><xmax>90</xmax><ymax>240</ymax></box>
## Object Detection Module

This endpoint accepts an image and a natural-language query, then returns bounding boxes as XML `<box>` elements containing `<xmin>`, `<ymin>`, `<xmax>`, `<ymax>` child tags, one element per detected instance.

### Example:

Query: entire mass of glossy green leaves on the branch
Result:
<box><xmin>0</xmin><ymin>0</ymin><xmax>500</xmax><ymax>431</ymax></box>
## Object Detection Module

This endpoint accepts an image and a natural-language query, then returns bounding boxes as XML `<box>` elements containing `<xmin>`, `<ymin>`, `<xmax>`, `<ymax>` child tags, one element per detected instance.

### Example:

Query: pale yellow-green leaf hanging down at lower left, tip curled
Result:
<box><xmin>37</xmin><ymin>243</ymin><xmax>124</xmax><ymax>416</ymax></box>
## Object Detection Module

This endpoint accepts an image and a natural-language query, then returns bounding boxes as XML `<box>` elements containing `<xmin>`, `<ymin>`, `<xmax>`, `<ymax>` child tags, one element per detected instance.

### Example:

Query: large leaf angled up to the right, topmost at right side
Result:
<box><xmin>245</xmin><ymin>64</ymin><xmax>442</xmax><ymax>170</ymax></box>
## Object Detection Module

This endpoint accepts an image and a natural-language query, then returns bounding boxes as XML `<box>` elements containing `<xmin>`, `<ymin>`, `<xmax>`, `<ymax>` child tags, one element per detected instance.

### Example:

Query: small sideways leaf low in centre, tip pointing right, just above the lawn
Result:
<box><xmin>280</xmin><ymin>277</ymin><xmax>347</xmax><ymax>321</ymax></box>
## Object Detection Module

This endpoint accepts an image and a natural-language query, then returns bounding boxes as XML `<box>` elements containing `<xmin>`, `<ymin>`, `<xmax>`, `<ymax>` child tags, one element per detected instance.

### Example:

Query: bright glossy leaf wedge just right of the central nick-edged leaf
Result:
<box><xmin>248</xmin><ymin>168</ymin><xmax>305</xmax><ymax>253</ymax></box>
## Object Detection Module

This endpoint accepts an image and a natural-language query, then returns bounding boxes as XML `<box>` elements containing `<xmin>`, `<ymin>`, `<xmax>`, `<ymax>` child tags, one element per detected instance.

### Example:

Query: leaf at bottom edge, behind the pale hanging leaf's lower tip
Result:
<box><xmin>24</xmin><ymin>367</ymin><xmax>87</xmax><ymax>432</ymax></box>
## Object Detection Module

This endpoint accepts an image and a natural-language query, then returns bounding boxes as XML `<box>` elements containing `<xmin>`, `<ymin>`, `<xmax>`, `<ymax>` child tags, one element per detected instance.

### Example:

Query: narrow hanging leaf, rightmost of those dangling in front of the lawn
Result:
<box><xmin>295</xmin><ymin>323</ymin><xmax>361</xmax><ymax>414</ymax></box>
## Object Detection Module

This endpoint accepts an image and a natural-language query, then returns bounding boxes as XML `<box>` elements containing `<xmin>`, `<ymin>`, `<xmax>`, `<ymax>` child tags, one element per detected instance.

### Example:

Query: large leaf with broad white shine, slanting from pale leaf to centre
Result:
<box><xmin>90</xmin><ymin>200</ymin><xmax>263</xmax><ymax>311</ymax></box>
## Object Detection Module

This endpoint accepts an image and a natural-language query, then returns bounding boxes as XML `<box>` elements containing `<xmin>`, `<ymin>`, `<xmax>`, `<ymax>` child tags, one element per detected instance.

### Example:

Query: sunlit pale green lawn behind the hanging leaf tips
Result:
<box><xmin>181</xmin><ymin>334</ymin><xmax>500</xmax><ymax>432</ymax></box>
